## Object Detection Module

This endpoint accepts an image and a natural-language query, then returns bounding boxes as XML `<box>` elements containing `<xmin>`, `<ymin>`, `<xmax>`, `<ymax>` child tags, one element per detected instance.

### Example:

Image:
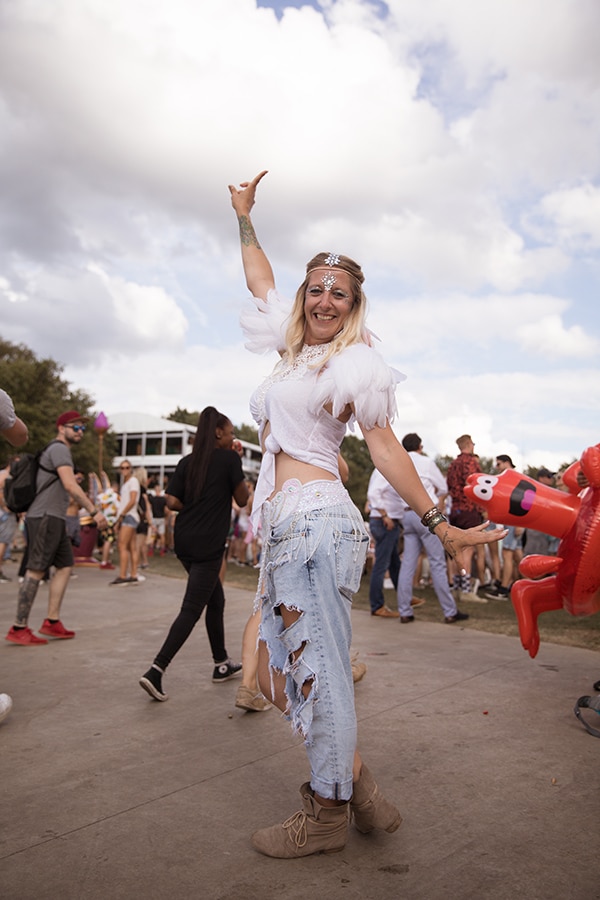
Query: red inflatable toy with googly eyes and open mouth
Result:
<box><xmin>465</xmin><ymin>444</ymin><xmax>600</xmax><ymax>658</ymax></box>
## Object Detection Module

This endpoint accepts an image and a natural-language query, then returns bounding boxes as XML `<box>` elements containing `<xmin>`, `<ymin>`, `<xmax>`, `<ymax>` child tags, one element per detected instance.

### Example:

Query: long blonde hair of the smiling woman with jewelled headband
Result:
<box><xmin>284</xmin><ymin>253</ymin><xmax>370</xmax><ymax>368</ymax></box>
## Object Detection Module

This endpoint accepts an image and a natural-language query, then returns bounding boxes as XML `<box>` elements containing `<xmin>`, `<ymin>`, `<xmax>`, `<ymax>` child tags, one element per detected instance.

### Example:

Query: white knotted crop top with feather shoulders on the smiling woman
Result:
<box><xmin>240</xmin><ymin>290</ymin><xmax>405</xmax><ymax>534</ymax></box>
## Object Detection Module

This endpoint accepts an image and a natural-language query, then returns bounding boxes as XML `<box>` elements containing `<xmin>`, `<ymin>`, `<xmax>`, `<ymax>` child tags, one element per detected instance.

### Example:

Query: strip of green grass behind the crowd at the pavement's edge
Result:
<box><xmin>143</xmin><ymin>556</ymin><xmax>600</xmax><ymax>650</ymax></box>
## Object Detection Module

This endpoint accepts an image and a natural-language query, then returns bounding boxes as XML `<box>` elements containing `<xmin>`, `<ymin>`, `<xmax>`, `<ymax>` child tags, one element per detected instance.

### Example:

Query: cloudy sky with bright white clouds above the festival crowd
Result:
<box><xmin>0</xmin><ymin>0</ymin><xmax>600</xmax><ymax>467</ymax></box>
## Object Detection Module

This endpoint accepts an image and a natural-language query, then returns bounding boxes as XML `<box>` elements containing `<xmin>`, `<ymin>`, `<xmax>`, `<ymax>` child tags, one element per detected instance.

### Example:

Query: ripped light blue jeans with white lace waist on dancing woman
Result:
<box><xmin>259</xmin><ymin>479</ymin><xmax>369</xmax><ymax>800</ymax></box>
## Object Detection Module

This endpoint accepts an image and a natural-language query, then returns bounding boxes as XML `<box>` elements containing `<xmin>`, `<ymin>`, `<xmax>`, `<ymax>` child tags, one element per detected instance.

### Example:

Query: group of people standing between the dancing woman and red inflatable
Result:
<box><xmin>367</xmin><ymin>433</ymin><xmax>566</xmax><ymax>624</ymax></box>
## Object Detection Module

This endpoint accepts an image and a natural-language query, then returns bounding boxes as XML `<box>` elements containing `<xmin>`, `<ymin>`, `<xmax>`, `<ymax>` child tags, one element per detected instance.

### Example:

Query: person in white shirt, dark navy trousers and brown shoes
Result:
<box><xmin>367</xmin><ymin>469</ymin><xmax>404</xmax><ymax>619</ymax></box>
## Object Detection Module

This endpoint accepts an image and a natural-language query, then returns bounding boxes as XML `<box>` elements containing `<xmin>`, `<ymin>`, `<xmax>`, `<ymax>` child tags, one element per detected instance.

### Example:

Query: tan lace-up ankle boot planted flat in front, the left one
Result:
<box><xmin>252</xmin><ymin>782</ymin><xmax>350</xmax><ymax>859</ymax></box>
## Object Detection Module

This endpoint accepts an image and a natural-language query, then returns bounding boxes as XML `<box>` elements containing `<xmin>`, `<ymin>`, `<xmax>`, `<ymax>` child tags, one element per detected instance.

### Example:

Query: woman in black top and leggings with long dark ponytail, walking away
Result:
<box><xmin>140</xmin><ymin>406</ymin><xmax>248</xmax><ymax>700</ymax></box>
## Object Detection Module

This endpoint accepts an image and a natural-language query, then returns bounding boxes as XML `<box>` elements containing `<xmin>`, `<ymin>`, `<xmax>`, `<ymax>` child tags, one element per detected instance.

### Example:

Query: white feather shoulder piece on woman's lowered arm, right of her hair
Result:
<box><xmin>312</xmin><ymin>344</ymin><xmax>406</xmax><ymax>429</ymax></box>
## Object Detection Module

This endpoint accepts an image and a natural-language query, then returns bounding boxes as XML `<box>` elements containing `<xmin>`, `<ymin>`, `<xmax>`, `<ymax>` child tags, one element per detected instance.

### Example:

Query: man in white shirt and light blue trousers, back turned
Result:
<box><xmin>398</xmin><ymin>432</ymin><xmax>469</xmax><ymax>625</ymax></box>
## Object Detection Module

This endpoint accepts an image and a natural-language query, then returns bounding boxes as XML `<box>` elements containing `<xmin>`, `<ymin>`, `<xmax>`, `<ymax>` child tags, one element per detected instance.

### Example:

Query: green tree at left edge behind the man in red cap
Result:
<box><xmin>0</xmin><ymin>339</ymin><xmax>115</xmax><ymax>475</ymax></box>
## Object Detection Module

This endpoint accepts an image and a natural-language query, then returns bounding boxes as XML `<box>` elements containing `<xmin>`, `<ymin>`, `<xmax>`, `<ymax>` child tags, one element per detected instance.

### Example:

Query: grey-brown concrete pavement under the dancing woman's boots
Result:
<box><xmin>0</xmin><ymin>568</ymin><xmax>600</xmax><ymax>900</ymax></box>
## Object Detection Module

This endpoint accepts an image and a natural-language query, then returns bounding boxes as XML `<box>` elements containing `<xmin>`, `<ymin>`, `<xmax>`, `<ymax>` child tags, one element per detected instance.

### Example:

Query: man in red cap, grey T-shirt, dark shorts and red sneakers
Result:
<box><xmin>6</xmin><ymin>409</ymin><xmax>107</xmax><ymax>646</ymax></box>
